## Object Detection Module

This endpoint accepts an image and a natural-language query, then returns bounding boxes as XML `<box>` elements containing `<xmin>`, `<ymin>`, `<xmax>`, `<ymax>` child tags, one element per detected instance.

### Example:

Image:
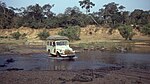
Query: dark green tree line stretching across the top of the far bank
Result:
<box><xmin>0</xmin><ymin>0</ymin><xmax>150</xmax><ymax>33</ymax></box>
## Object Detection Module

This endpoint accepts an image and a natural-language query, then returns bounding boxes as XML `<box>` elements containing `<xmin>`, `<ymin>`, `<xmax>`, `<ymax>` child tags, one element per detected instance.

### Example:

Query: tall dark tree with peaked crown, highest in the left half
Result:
<box><xmin>23</xmin><ymin>4</ymin><xmax>44</xmax><ymax>28</ymax></box>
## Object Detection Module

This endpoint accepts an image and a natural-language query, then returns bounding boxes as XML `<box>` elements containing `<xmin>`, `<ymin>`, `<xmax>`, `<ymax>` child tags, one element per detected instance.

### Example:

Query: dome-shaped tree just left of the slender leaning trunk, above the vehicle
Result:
<box><xmin>61</xmin><ymin>6</ymin><xmax>90</xmax><ymax>27</ymax></box>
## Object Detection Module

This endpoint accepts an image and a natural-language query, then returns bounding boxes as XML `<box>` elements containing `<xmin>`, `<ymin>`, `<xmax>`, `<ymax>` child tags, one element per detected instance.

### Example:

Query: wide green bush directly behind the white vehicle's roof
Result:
<box><xmin>58</xmin><ymin>26</ymin><xmax>81</xmax><ymax>40</ymax></box>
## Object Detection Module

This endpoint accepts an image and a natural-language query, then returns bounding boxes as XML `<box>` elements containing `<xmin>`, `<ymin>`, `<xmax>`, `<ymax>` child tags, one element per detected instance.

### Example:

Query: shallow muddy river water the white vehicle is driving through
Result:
<box><xmin>0</xmin><ymin>50</ymin><xmax>150</xmax><ymax>71</ymax></box>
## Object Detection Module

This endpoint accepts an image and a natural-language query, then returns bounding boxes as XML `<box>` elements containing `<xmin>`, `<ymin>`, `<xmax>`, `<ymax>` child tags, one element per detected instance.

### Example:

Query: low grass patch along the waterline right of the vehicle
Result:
<box><xmin>72</xmin><ymin>42</ymin><xmax>134</xmax><ymax>52</ymax></box>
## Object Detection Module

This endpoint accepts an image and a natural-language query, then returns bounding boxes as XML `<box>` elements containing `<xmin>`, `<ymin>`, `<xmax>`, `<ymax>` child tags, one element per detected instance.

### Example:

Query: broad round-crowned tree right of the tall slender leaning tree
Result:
<box><xmin>100</xmin><ymin>2</ymin><xmax>124</xmax><ymax>27</ymax></box>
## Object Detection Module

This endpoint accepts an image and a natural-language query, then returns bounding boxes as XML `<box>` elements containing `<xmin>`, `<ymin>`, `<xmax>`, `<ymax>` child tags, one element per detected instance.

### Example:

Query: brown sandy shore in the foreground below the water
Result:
<box><xmin>0</xmin><ymin>68</ymin><xmax>150</xmax><ymax>84</ymax></box>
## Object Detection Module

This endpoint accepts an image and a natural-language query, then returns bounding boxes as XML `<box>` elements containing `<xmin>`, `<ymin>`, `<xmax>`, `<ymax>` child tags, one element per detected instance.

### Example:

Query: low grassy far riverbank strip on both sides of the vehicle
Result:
<box><xmin>0</xmin><ymin>41</ymin><xmax>150</xmax><ymax>55</ymax></box>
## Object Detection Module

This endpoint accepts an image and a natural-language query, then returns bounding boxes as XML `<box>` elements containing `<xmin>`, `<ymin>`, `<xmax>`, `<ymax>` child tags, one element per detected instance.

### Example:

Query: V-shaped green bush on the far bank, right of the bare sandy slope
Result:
<box><xmin>118</xmin><ymin>25</ymin><xmax>135</xmax><ymax>40</ymax></box>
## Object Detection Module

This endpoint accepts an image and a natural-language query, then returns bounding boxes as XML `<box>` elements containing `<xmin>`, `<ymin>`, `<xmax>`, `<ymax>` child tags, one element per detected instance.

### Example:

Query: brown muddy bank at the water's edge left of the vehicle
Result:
<box><xmin>0</xmin><ymin>44</ymin><xmax>47</xmax><ymax>56</ymax></box>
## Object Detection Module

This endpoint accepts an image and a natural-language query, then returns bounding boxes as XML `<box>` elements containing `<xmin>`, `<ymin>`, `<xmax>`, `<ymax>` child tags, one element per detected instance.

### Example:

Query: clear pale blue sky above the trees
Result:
<box><xmin>0</xmin><ymin>0</ymin><xmax>150</xmax><ymax>14</ymax></box>
